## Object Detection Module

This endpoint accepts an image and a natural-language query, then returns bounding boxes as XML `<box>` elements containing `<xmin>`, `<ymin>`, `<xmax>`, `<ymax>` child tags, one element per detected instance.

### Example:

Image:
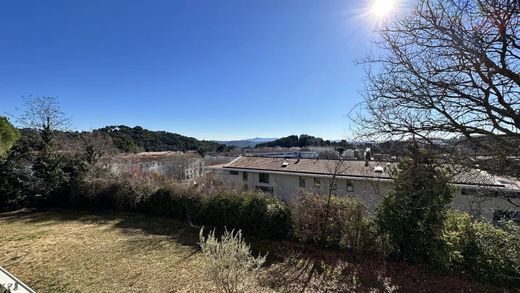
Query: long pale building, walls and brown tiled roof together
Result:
<box><xmin>206</xmin><ymin>157</ymin><xmax>520</xmax><ymax>220</ymax></box>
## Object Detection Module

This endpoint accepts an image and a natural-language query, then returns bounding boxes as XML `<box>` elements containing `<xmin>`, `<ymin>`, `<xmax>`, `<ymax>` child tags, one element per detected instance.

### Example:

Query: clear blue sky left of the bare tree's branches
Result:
<box><xmin>0</xmin><ymin>0</ymin><xmax>390</xmax><ymax>140</ymax></box>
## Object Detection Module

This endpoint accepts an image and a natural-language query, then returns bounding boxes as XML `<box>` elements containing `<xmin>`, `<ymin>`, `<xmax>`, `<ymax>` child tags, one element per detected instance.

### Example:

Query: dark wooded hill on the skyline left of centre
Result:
<box><xmin>94</xmin><ymin>125</ymin><xmax>228</xmax><ymax>154</ymax></box>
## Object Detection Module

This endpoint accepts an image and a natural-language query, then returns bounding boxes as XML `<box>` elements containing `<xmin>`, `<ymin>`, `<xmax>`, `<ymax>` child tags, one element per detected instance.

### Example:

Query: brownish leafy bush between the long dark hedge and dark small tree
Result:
<box><xmin>292</xmin><ymin>194</ymin><xmax>376</xmax><ymax>251</ymax></box>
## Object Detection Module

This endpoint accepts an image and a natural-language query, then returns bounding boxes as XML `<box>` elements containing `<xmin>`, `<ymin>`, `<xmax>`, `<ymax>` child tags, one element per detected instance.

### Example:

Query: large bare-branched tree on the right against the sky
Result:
<box><xmin>356</xmin><ymin>0</ymin><xmax>520</xmax><ymax>176</ymax></box>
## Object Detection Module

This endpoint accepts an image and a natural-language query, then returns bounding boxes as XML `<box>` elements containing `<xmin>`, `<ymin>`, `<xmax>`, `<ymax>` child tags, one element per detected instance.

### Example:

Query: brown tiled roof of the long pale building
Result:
<box><xmin>213</xmin><ymin>157</ymin><xmax>505</xmax><ymax>187</ymax></box>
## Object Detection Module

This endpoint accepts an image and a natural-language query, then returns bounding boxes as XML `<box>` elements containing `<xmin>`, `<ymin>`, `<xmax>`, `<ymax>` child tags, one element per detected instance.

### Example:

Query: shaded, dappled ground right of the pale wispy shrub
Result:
<box><xmin>256</xmin><ymin>242</ymin><xmax>510</xmax><ymax>292</ymax></box>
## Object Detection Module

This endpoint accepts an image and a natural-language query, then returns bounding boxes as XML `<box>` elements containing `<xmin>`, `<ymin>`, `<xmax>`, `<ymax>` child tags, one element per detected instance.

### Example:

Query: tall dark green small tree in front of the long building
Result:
<box><xmin>376</xmin><ymin>150</ymin><xmax>454</xmax><ymax>263</ymax></box>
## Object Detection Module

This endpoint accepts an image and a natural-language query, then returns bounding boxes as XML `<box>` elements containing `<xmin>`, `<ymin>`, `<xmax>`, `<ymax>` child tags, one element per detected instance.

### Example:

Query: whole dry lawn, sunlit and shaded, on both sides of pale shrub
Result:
<box><xmin>0</xmin><ymin>210</ymin><xmax>514</xmax><ymax>292</ymax></box>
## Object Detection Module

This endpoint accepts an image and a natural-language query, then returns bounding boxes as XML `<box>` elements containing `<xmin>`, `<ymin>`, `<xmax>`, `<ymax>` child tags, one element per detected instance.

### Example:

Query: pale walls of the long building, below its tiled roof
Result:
<box><xmin>210</xmin><ymin>170</ymin><xmax>519</xmax><ymax>220</ymax></box>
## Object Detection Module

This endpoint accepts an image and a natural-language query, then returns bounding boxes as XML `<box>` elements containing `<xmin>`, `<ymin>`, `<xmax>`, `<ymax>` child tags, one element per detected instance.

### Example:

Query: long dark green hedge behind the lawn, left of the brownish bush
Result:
<box><xmin>70</xmin><ymin>175</ymin><xmax>293</xmax><ymax>239</ymax></box>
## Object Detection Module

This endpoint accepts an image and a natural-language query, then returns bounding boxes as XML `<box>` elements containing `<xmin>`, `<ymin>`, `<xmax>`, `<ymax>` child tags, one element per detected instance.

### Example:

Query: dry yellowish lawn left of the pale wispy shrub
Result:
<box><xmin>0</xmin><ymin>211</ymin><xmax>214</xmax><ymax>292</ymax></box>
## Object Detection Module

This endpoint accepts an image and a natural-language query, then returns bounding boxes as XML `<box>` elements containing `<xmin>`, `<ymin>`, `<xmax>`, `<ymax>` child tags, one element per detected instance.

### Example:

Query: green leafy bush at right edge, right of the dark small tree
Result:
<box><xmin>443</xmin><ymin>211</ymin><xmax>520</xmax><ymax>286</ymax></box>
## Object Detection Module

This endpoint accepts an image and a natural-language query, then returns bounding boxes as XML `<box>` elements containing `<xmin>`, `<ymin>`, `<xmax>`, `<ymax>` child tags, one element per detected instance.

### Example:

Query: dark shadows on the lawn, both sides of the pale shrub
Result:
<box><xmin>0</xmin><ymin>209</ymin><xmax>518</xmax><ymax>292</ymax></box>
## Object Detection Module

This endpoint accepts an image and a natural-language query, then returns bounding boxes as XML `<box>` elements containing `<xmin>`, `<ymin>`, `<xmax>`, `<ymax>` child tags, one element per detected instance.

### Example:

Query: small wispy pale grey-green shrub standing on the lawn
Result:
<box><xmin>199</xmin><ymin>229</ymin><xmax>266</xmax><ymax>293</ymax></box>
